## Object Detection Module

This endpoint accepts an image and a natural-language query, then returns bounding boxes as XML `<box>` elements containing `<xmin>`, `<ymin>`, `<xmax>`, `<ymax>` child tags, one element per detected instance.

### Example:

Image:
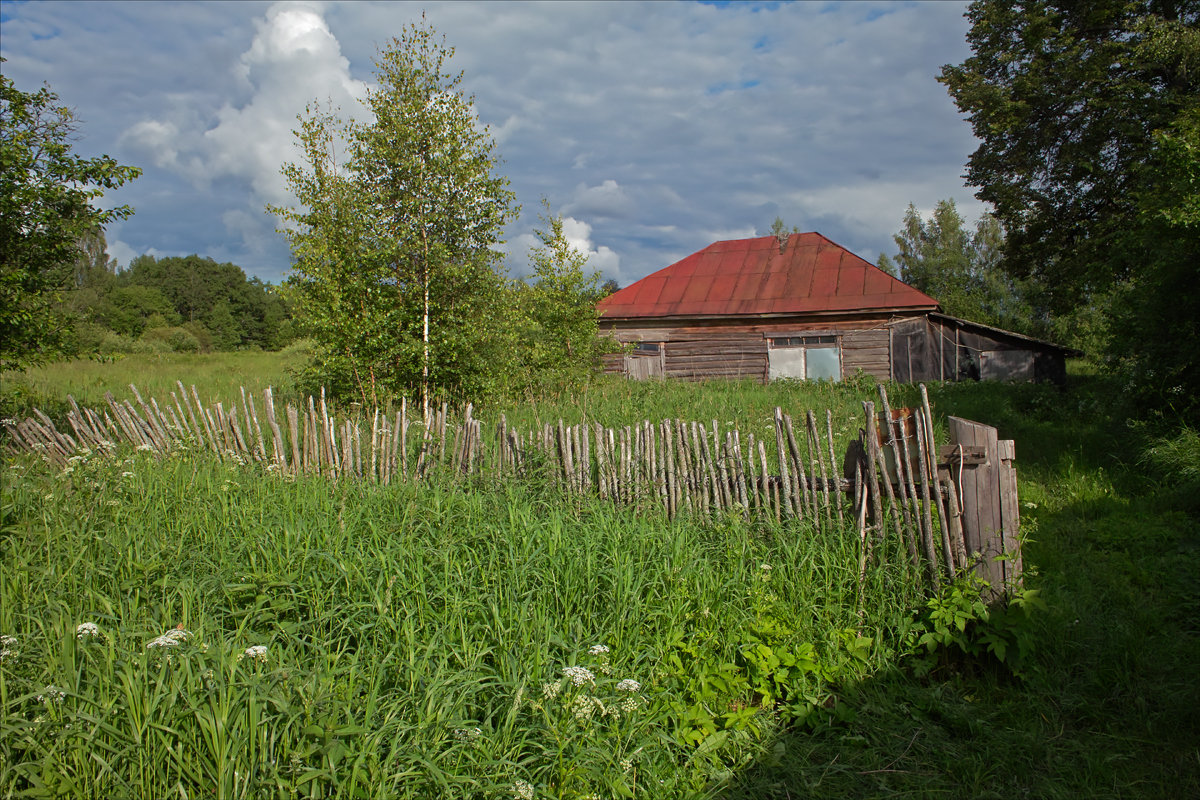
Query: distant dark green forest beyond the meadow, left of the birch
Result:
<box><xmin>65</xmin><ymin>231</ymin><xmax>296</xmax><ymax>355</ymax></box>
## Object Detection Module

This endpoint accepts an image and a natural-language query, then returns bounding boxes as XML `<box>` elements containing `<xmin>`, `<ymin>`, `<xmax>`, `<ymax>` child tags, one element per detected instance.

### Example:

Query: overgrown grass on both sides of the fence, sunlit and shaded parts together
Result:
<box><xmin>0</xmin><ymin>357</ymin><xmax>1200</xmax><ymax>798</ymax></box>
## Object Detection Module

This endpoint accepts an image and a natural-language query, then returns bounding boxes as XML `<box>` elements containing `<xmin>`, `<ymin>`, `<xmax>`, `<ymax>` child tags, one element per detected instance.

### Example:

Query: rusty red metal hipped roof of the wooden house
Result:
<box><xmin>596</xmin><ymin>233</ymin><xmax>937</xmax><ymax>319</ymax></box>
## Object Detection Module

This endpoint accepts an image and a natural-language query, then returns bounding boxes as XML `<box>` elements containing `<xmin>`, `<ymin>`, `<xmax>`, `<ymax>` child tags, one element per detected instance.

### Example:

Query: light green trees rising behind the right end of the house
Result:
<box><xmin>880</xmin><ymin>200</ymin><xmax>1044</xmax><ymax>333</ymax></box>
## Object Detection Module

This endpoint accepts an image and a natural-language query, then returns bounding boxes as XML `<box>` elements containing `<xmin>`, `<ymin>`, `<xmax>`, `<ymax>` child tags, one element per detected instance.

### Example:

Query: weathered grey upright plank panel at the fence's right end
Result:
<box><xmin>947</xmin><ymin>416</ymin><xmax>1021</xmax><ymax>600</ymax></box>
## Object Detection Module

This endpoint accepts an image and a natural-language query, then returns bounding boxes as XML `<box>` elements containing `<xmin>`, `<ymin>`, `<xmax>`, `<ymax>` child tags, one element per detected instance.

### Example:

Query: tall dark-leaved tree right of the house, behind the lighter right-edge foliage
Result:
<box><xmin>940</xmin><ymin>0</ymin><xmax>1200</xmax><ymax>313</ymax></box>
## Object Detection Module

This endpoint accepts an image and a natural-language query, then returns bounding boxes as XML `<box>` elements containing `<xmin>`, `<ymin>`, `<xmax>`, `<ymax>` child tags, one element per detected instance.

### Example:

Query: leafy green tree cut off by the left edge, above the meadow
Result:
<box><xmin>0</xmin><ymin>67</ymin><xmax>140</xmax><ymax>369</ymax></box>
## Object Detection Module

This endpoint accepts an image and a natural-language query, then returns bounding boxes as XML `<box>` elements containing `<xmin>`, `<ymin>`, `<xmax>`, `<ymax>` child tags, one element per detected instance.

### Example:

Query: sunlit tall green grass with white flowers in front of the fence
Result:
<box><xmin>0</xmin><ymin>443</ymin><xmax>916</xmax><ymax>798</ymax></box>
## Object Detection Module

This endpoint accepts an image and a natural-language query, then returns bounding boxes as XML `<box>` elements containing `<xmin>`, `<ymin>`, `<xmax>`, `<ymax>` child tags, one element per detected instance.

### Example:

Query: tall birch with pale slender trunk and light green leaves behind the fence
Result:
<box><xmin>275</xmin><ymin>20</ymin><xmax>515</xmax><ymax>408</ymax></box>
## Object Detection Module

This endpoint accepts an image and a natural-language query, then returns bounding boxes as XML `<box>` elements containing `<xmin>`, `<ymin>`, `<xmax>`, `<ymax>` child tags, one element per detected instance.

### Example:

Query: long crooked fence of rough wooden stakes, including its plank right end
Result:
<box><xmin>5</xmin><ymin>383</ymin><xmax>1021</xmax><ymax>595</ymax></box>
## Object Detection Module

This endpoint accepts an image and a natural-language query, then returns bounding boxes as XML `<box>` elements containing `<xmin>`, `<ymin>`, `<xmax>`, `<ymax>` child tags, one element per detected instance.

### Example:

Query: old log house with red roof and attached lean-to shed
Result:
<box><xmin>598</xmin><ymin>233</ymin><xmax>1072</xmax><ymax>381</ymax></box>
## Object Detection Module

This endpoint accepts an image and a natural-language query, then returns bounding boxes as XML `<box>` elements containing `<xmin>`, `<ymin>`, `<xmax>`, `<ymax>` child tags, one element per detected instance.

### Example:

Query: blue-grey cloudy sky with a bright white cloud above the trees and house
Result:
<box><xmin>0</xmin><ymin>1</ymin><xmax>983</xmax><ymax>285</ymax></box>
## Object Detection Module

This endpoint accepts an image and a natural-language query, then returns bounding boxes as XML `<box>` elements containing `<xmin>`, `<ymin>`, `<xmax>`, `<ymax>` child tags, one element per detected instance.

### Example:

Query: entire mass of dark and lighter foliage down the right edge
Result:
<box><xmin>941</xmin><ymin>0</ymin><xmax>1200</xmax><ymax>414</ymax></box>
